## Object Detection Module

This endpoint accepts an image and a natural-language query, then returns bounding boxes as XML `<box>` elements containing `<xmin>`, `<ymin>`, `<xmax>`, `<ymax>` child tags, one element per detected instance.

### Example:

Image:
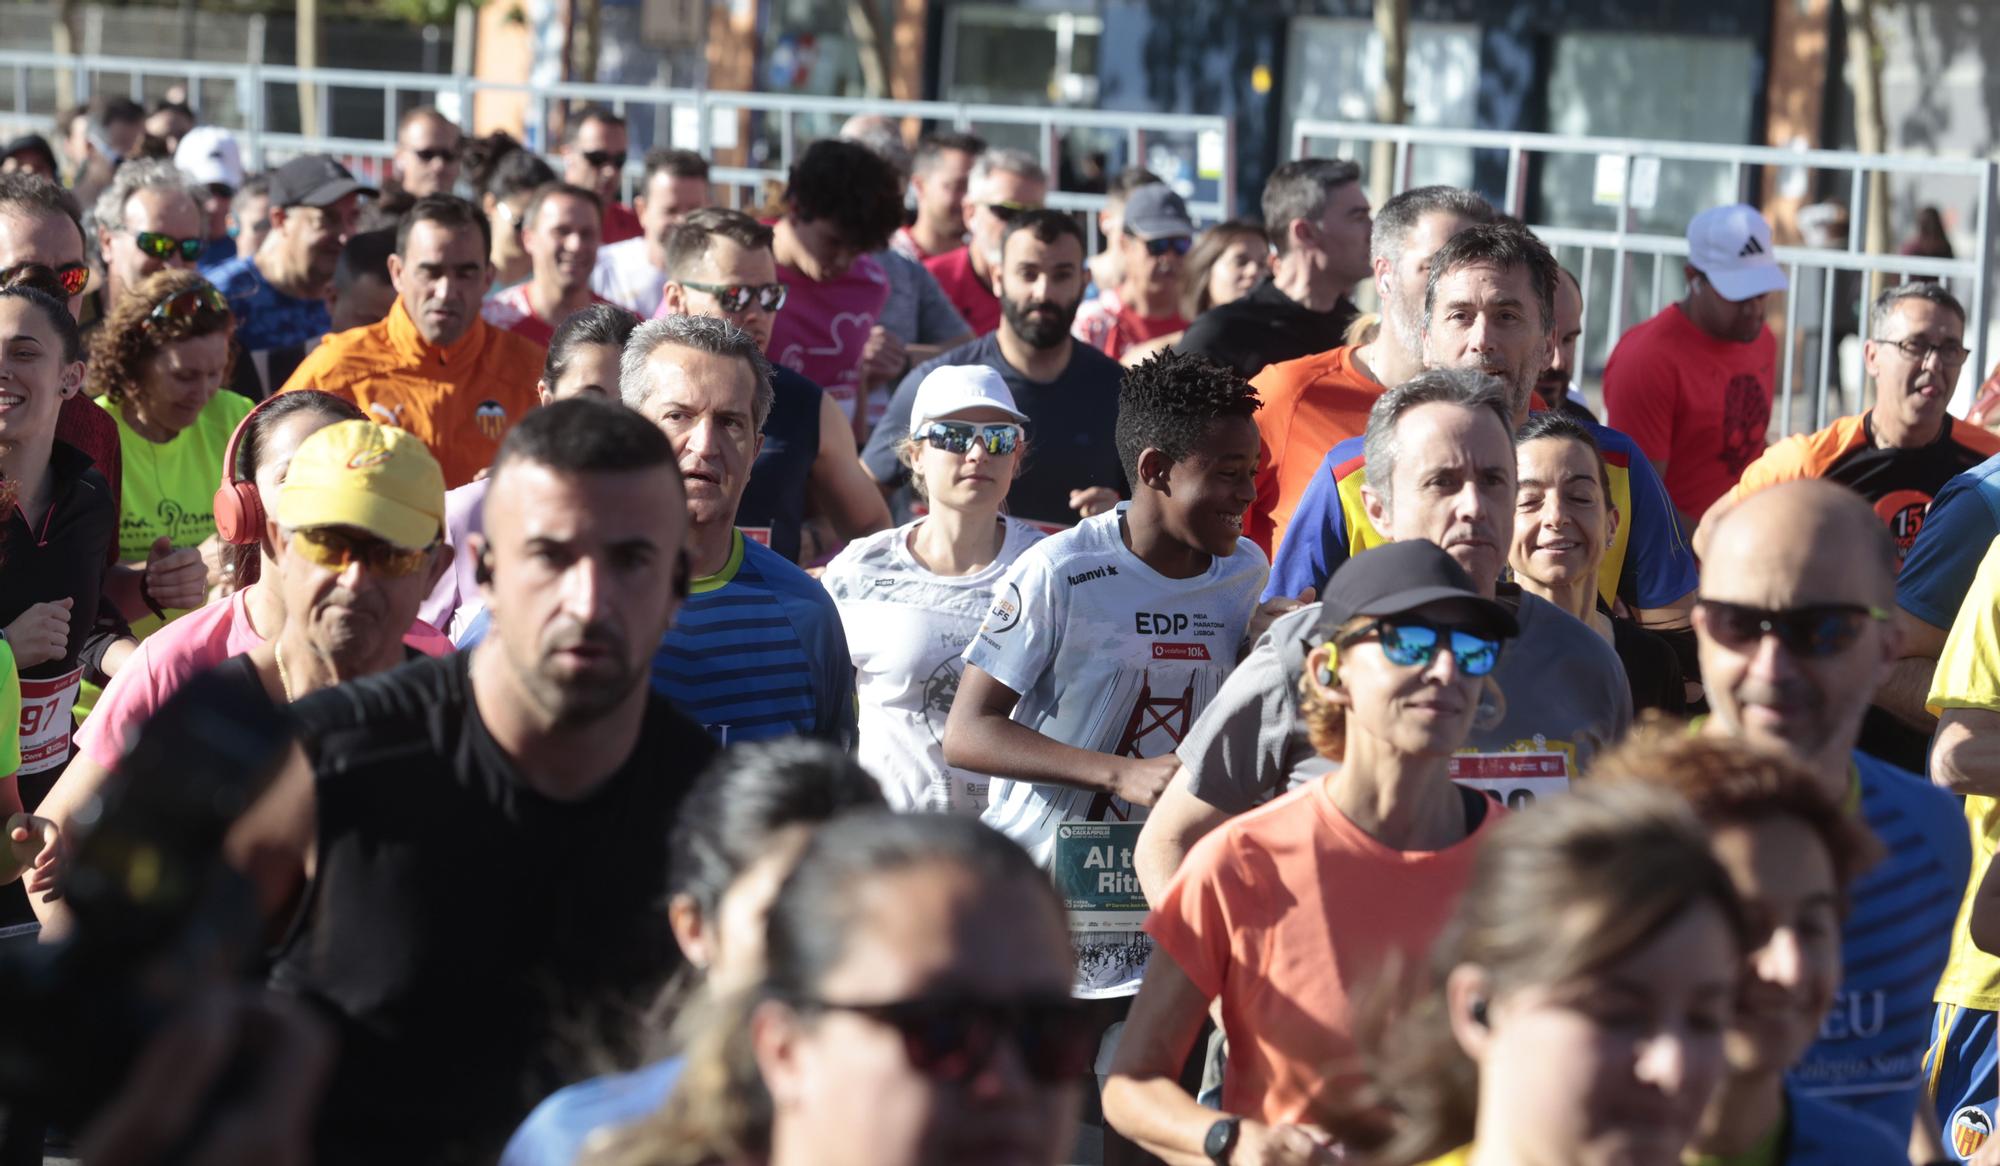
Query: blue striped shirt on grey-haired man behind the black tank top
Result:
<box><xmin>652</xmin><ymin>532</ymin><xmax>854</xmax><ymax>746</ymax></box>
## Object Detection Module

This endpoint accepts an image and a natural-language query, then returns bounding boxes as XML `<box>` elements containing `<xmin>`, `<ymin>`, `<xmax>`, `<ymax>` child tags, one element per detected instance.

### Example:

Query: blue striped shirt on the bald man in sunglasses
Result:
<box><xmin>1790</xmin><ymin>750</ymin><xmax>1972</xmax><ymax>1130</ymax></box>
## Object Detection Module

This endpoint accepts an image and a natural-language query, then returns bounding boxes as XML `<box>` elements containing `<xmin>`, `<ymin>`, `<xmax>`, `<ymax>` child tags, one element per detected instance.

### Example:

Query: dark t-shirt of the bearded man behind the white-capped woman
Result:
<box><xmin>862</xmin><ymin>332</ymin><xmax>1130</xmax><ymax>526</ymax></box>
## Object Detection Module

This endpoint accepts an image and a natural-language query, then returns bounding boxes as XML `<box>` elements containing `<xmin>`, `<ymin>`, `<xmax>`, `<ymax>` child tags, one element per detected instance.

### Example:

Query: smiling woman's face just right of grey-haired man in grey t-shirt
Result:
<box><xmin>1508</xmin><ymin>438</ymin><xmax>1616</xmax><ymax>586</ymax></box>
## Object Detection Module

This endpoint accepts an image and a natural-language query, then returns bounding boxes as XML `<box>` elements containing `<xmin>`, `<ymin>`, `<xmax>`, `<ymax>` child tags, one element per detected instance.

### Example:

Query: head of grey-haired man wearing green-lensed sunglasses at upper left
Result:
<box><xmin>84</xmin><ymin>158</ymin><xmax>206</xmax><ymax>328</ymax></box>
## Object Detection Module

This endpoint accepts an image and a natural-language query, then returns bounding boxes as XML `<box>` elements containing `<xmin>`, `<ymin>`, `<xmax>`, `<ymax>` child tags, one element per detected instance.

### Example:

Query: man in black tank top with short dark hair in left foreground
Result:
<box><xmin>232</xmin><ymin>398</ymin><xmax>714</xmax><ymax>1164</ymax></box>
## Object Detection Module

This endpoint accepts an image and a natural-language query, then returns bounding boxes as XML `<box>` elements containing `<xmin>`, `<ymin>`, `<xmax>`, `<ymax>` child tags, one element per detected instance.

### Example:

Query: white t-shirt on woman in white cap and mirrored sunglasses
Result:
<box><xmin>820</xmin><ymin>516</ymin><xmax>1042</xmax><ymax>814</ymax></box>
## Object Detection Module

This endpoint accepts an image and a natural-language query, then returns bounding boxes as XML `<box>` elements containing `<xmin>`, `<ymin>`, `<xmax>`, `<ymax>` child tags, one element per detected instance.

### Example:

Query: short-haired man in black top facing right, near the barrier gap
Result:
<box><xmin>1174</xmin><ymin>158</ymin><xmax>1374</xmax><ymax>378</ymax></box>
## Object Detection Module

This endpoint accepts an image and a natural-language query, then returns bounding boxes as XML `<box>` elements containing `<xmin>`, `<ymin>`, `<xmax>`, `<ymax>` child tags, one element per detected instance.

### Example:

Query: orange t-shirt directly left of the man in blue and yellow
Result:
<box><xmin>1244</xmin><ymin>344</ymin><xmax>1382</xmax><ymax>556</ymax></box>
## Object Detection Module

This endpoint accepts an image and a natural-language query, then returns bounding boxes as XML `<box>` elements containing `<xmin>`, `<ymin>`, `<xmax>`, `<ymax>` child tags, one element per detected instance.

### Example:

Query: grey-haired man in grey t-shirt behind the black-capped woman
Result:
<box><xmin>1138</xmin><ymin>368</ymin><xmax>1632</xmax><ymax>896</ymax></box>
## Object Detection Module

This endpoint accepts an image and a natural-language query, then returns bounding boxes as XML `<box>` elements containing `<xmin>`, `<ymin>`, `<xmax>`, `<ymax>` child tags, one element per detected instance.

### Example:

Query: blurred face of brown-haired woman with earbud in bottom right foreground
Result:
<box><xmin>1460</xmin><ymin>902</ymin><xmax>1740</xmax><ymax>1166</ymax></box>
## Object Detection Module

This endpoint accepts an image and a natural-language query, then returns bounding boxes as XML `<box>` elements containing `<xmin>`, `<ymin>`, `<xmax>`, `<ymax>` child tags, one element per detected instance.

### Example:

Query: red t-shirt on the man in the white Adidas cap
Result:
<box><xmin>1604</xmin><ymin>304</ymin><xmax>1778</xmax><ymax>518</ymax></box>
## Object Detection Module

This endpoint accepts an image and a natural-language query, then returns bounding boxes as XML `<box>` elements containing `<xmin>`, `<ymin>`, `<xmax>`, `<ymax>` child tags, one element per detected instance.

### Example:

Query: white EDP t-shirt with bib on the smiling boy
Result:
<box><xmin>966</xmin><ymin>504</ymin><xmax>1270</xmax><ymax>998</ymax></box>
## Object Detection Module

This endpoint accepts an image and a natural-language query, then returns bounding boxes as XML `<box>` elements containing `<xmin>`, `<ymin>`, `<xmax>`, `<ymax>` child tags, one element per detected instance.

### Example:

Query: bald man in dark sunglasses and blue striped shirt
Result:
<box><xmin>1694</xmin><ymin>480</ymin><xmax>1970</xmax><ymax>1162</ymax></box>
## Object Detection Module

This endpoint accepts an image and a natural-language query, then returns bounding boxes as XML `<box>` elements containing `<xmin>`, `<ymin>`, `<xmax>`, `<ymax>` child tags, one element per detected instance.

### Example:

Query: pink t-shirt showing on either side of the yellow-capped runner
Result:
<box><xmin>76</xmin><ymin>592</ymin><xmax>452</xmax><ymax>768</ymax></box>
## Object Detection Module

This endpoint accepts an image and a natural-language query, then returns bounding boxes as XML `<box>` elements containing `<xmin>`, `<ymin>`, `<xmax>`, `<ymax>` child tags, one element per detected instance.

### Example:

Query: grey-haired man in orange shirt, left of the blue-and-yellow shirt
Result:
<box><xmin>1244</xmin><ymin>186</ymin><xmax>1496</xmax><ymax>562</ymax></box>
